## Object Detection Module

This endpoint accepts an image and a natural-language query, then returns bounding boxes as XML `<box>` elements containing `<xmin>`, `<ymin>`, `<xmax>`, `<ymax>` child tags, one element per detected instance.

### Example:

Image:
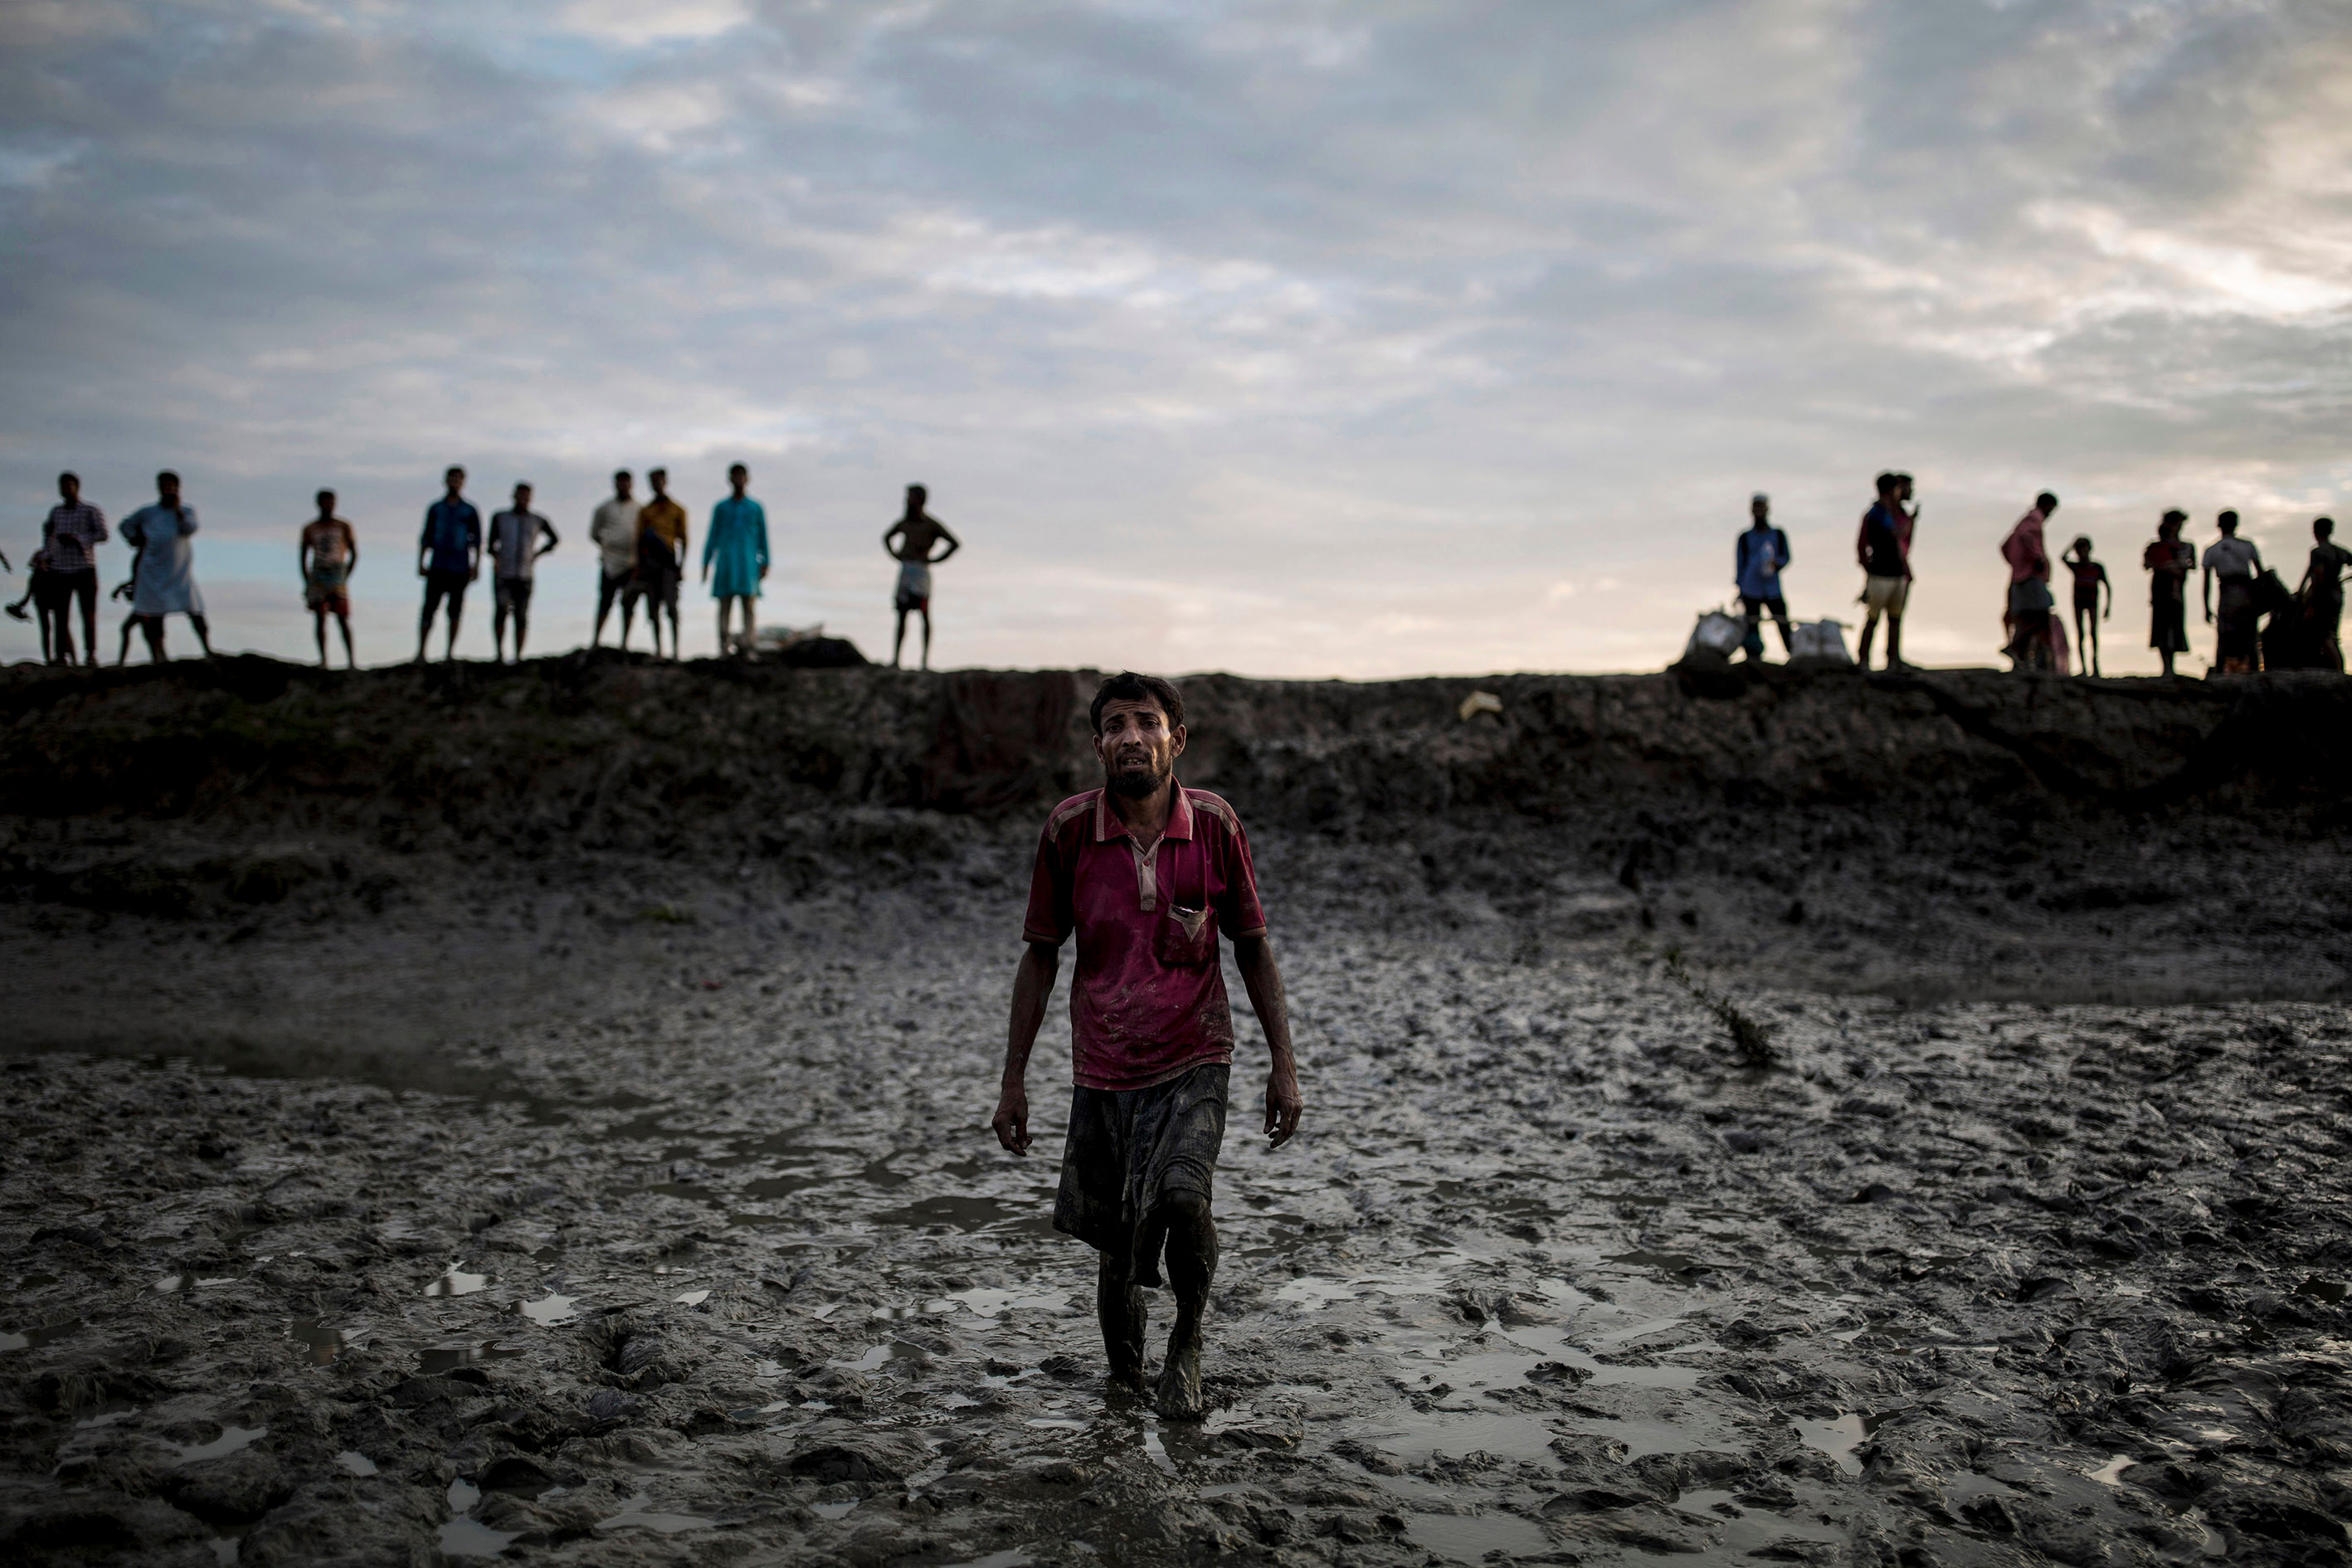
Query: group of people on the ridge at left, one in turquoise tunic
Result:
<box><xmin>0</xmin><ymin>463</ymin><xmax>962</xmax><ymax>668</ymax></box>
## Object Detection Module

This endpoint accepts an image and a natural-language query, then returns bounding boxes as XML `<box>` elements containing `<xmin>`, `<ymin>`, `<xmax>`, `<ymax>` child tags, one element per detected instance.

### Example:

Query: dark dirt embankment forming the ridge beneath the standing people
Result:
<box><xmin>0</xmin><ymin>656</ymin><xmax>2352</xmax><ymax>999</ymax></box>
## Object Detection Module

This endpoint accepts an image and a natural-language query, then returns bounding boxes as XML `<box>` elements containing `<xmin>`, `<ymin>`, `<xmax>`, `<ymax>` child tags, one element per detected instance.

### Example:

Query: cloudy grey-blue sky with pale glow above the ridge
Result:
<box><xmin>0</xmin><ymin>0</ymin><xmax>2352</xmax><ymax>677</ymax></box>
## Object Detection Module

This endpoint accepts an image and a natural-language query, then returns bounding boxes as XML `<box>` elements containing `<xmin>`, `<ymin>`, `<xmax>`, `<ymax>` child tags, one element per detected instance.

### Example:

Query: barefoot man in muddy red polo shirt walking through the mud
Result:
<box><xmin>995</xmin><ymin>674</ymin><xmax>1301</xmax><ymax>1419</ymax></box>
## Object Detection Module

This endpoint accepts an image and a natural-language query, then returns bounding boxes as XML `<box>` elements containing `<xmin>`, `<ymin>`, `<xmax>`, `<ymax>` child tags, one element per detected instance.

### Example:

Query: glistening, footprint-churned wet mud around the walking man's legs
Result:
<box><xmin>0</xmin><ymin>893</ymin><xmax>2352</xmax><ymax>1568</ymax></box>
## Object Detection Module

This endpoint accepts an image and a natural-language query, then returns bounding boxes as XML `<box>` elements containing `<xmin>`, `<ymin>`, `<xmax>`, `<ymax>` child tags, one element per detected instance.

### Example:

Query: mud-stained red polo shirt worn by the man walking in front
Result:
<box><xmin>1020</xmin><ymin>785</ymin><xmax>1265</xmax><ymax>1088</ymax></box>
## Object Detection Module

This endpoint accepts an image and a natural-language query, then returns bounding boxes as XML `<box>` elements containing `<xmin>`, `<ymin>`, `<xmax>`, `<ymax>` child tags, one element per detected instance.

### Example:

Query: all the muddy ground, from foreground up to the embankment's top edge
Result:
<box><xmin>0</xmin><ymin>660</ymin><xmax>2352</xmax><ymax>1568</ymax></box>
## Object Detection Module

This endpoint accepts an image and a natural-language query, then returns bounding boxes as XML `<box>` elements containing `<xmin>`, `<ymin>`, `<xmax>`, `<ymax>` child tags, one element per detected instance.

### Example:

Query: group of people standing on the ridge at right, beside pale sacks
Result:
<box><xmin>1731</xmin><ymin>473</ymin><xmax>2352</xmax><ymax>674</ymax></box>
